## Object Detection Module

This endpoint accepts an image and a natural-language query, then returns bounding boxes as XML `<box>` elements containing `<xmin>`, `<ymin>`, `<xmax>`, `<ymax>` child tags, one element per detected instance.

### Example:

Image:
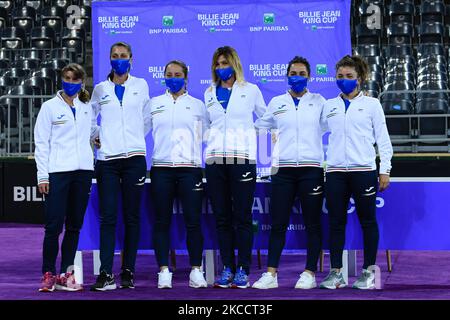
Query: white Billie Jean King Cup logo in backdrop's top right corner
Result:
<box><xmin>298</xmin><ymin>10</ymin><xmax>341</xmax><ymax>31</ymax></box>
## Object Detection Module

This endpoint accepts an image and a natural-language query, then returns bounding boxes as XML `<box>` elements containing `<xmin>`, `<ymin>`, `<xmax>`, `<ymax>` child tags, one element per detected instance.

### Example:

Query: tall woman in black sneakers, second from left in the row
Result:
<box><xmin>91</xmin><ymin>42</ymin><xmax>150</xmax><ymax>291</ymax></box>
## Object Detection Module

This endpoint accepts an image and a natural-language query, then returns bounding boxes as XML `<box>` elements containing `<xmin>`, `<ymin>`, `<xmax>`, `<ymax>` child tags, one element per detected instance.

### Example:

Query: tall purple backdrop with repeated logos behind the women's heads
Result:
<box><xmin>92</xmin><ymin>0</ymin><xmax>351</xmax><ymax>170</ymax></box>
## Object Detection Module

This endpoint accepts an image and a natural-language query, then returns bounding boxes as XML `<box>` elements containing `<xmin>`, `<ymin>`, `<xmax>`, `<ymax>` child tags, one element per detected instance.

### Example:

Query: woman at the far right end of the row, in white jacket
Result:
<box><xmin>320</xmin><ymin>55</ymin><xmax>393</xmax><ymax>289</ymax></box>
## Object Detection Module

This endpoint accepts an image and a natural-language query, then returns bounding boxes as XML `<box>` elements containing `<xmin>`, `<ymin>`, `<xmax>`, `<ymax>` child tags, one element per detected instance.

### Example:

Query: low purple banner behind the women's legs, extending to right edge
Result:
<box><xmin>79</xmin><ymin>179</ymin><xmax>450</xmax><ymax>250</ymax></box>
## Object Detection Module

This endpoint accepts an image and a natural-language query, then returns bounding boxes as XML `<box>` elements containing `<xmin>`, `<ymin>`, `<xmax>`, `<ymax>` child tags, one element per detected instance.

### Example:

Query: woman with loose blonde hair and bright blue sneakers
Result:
<box><xmin>205</xmin><ymin>46</ymin><xmax>266</xmax><ymax>288</ymax></box>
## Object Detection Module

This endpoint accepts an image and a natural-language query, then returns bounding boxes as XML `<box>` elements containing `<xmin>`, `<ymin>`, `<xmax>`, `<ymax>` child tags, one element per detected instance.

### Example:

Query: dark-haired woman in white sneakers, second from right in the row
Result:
<box><xmin>253</xmin><ymin>56</ymin><xmax>325</xmax><ymax>289</ymax></box>
